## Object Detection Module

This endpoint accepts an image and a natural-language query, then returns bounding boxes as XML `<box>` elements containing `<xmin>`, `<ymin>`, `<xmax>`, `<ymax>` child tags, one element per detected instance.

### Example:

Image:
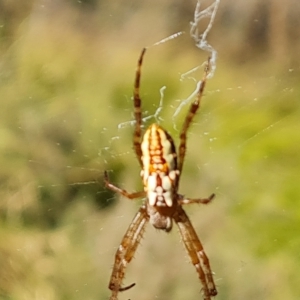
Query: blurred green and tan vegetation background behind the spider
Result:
<box><xmin>0</xmin><ymin>0</ymin><xmax>300</xmax><ymax>300</ymax></box>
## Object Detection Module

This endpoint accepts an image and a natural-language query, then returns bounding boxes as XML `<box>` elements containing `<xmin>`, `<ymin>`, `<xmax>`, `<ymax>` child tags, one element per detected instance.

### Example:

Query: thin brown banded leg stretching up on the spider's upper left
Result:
<box><xmin>133</xmin><ymin>48</ymin><xmax>146</xmax><ymax>167</ymax></box>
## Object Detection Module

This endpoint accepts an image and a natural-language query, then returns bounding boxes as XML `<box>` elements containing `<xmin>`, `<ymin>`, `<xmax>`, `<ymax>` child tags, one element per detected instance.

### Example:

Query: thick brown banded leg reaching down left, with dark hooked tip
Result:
<box><xmin>108</xmin><ymin>205</ymin><xmax>149</xmax><ymax>300</ymax></box>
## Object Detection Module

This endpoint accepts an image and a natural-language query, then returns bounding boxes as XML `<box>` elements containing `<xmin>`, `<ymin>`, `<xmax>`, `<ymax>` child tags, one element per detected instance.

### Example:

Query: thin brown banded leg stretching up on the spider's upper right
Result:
<box><xmin>178</xmin><ymin>58</ymin><xmax>210</xmax><ymax>174</ymax></box>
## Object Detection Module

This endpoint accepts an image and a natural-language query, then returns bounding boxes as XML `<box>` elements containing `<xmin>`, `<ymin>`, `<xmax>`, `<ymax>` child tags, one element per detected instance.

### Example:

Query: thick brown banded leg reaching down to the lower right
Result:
<box><xmin>174</xmin><ymin>207</ymin><xmax>218</xmax><ymax>300</ymax></box>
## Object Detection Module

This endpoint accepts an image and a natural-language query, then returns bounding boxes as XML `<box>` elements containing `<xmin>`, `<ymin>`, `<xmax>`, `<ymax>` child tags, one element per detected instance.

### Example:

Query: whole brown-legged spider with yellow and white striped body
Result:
<box><xmin>104</xmin><ymin>48</ymin><xmax>217</xmax><ymax>300</ymax></box>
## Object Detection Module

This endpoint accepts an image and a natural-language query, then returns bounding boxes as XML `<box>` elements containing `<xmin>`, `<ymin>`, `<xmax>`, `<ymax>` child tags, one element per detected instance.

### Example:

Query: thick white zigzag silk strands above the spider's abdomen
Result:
<box><xmin>103</xmin><ymin>0</ymin><xmax>225</xmax><ymax>299</ymax></box>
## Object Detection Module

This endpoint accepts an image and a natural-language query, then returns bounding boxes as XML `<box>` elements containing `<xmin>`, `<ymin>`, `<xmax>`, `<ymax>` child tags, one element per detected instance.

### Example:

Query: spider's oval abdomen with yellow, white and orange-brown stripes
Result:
<box><xmin>141</xmin><ymin>124</ymin><xmax>179</xmax><ymax>207</ymax></box>
